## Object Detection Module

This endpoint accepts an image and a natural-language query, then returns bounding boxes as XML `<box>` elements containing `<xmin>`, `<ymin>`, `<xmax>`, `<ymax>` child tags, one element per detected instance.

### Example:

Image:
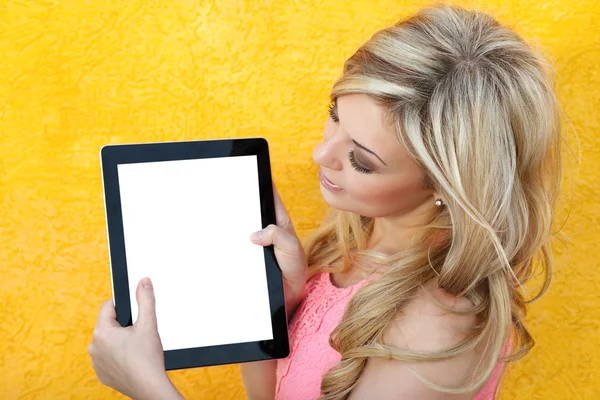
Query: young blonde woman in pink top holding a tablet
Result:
<box><xmin>90</xmin><ymin>6</ymin><xmax>562</xmax><ymax>400</ymax></box>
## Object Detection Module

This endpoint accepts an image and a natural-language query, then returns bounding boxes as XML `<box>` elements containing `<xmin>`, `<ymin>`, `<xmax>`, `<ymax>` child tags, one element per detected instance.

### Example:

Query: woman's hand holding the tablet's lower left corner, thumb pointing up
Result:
<box><xmin>88</xmin><ymin>278</ymin><xmax>183</xmax><ymax>399</ymax></box>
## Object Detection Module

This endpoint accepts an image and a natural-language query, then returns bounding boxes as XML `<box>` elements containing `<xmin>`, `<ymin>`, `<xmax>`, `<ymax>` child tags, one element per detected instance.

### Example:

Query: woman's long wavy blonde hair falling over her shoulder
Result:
<box><xmin>306</xmin><ymin>5</ymin><xmax>562</xmax><ymax>399</ymax></box>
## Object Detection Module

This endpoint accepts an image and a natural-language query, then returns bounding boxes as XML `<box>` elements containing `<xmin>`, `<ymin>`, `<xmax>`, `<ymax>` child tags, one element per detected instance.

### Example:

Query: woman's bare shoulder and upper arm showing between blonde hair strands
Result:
<box><xmin>349</xmin><ymin>282</ymin><xmax>481</xmax><ymax>400</ymax></box>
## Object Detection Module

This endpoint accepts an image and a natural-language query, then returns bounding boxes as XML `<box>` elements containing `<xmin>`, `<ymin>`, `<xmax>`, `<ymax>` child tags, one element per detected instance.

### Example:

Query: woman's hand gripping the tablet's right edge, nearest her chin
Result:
<box><xmin>250</xmin><ymin>185</ymin><xmax>308</xmax><ymax>317</ymax></box>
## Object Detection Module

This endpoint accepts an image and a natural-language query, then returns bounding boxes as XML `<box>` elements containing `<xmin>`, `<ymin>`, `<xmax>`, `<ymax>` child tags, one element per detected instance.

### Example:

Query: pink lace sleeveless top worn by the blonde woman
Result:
<box><xmin>275</xmin><ymin>273</ymin><xmax>510</xmax><ymax>400</ymax></box>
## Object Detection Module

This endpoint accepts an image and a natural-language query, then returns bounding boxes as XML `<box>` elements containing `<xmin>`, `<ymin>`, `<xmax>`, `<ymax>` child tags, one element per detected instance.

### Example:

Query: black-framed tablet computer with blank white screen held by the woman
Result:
<box><xmin>100</xmin><ymin>138</ymin><xmax>289</xmax><ymax>370</ymax></box>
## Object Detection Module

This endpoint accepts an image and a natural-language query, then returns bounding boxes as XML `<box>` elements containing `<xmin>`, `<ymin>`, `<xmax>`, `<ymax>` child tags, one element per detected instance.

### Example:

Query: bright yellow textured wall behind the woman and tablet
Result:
<box><xmin>0</xmin><ymin>0</ymin><xmax>600</xmax><ymax>399</ymax></box>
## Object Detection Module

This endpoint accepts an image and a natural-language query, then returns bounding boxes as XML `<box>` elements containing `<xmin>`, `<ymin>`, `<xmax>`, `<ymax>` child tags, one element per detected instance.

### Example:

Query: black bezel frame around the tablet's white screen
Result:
<box><xmin>100</xmin><ymin>138</ymin><xmax>289</xmax><ymax>370</ymax></box>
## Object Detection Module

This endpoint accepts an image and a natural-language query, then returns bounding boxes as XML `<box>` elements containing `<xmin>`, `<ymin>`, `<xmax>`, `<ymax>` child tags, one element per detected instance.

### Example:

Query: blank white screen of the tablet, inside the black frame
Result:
<box><xmin>117</xmin><ymin>156</ymin><xmax>273</xmax><ymax>350</ymax></box>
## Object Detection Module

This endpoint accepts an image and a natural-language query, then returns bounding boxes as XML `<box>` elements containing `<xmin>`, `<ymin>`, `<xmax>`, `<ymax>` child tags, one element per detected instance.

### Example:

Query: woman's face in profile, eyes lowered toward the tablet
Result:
<box><xmin>313</xmin><ymin>94</ymin><xmax>435</xmax><ymax>217</ymax></box>
